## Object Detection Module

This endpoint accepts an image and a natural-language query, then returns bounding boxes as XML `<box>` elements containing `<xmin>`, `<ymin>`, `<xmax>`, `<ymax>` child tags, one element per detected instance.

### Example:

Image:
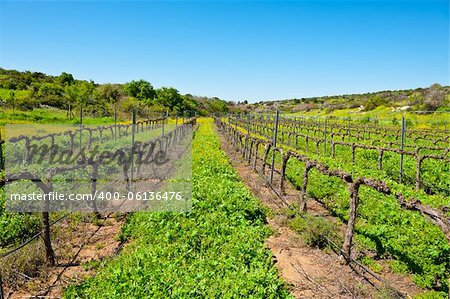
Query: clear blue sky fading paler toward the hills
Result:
<box><xmin>0</xmin><ymin>0</ymin><xmax>449</xmax><ymax>102</ymax></box>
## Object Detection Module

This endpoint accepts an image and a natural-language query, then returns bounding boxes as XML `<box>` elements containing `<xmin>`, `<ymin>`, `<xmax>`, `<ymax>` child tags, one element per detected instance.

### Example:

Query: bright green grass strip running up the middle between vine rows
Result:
<box><xmin>65</xmin><ymin>120</ymin><xmax>290</xmax><ymax>298</ymax></box>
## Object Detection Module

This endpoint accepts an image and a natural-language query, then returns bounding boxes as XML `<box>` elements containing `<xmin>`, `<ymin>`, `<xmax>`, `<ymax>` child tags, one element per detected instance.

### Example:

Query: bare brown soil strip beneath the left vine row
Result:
<box><xmin>5</xmin><ymin>217</ymin><xmax>123</xmax><ymax>298</ymax></box>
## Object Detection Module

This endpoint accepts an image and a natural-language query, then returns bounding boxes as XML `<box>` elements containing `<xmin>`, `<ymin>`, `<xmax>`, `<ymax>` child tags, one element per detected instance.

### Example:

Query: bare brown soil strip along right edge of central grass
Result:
<box><xmin>215</xmin><ymin>125</ymin><xmax>420</xmax><ymax>298</ymax></box>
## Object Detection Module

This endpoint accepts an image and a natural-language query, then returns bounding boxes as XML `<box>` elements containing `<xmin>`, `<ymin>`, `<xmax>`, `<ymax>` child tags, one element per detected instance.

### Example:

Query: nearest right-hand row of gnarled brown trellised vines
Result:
<box><xmin>215</xmin><ymin>115</ymin><xmax>450</xmax><ymax>295</ymax></box>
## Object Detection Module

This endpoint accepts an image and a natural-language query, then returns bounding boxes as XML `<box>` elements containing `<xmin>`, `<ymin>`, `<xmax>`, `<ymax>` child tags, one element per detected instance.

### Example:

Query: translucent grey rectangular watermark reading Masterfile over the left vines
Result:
<box><xmin>5</xmin><ymin>124</ymin><xmax>192</xmax><ymax>212</ymax></box>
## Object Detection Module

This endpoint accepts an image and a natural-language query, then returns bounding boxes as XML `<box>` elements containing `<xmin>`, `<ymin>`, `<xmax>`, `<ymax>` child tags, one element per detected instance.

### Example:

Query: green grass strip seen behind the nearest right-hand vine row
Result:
<box><xmin>227</xmin><ymin>119</ymin><xmax>450</xmax><ymax>295</ymax></box>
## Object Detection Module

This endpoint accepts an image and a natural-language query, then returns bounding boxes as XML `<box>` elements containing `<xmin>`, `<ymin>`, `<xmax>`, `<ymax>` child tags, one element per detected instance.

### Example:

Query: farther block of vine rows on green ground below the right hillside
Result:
<box><xmin>225</xmin><ymin>114</ymin><xmax>450</xmax><ymax>195</ymax></box>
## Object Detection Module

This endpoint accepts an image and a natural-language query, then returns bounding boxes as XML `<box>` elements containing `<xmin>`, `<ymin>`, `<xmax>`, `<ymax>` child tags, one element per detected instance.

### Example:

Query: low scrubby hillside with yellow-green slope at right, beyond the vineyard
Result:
<box><xmin>243</xmin><ymin>84</ymin><xmax>450</xmax><ymax>128</ymax></box>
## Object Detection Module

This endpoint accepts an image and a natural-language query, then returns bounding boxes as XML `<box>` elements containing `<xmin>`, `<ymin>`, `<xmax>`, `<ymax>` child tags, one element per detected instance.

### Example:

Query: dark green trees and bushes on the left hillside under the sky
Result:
<box><xmin>0</xmin><ymin>68</ymin><xmax>233</xmax><ymax>118</ymax></box>
